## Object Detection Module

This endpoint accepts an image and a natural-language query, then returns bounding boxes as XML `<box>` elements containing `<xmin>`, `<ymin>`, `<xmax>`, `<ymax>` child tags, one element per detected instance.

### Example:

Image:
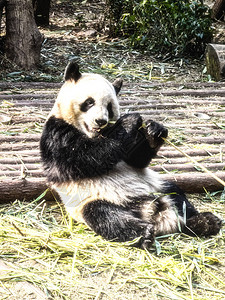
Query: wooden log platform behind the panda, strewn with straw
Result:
<box><xmin>0</xmin><ymin>82</ymin><xmax>225</xmax><ymax>202</ymax></box>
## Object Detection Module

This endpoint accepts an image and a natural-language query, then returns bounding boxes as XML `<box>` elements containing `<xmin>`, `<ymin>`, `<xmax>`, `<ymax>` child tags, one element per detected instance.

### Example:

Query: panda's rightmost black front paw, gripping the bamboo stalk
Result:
<box><xmin>145</xmin><ymin>120</ymin><xmax>168</xmax><ymax>149</ymax></box>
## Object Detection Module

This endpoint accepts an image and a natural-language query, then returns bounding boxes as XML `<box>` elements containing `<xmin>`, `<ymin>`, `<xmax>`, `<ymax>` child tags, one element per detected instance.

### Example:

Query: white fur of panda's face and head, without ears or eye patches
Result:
<box><xmin>50</xmin><ymin>74</ymin><xmax>120</xmax><ymax>138</ymax></box>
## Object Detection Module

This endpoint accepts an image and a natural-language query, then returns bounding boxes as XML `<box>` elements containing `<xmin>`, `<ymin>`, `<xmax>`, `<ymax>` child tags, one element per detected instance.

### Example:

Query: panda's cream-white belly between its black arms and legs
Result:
<box><xmin>53</xmin><ymin>162</ymin><xmax>162</xmax><ymax>222</ymax></box>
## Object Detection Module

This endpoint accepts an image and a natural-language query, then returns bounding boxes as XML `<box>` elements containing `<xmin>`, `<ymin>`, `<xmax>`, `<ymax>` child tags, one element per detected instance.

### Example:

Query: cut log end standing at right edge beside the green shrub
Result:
<box><xmin>206</xmin><ymin>44</ymin><xmax>225</xmax><ymax>81</ymax></box>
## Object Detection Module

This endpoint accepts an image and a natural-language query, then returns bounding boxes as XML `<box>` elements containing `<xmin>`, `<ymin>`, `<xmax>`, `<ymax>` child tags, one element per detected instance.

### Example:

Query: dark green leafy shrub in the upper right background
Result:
<box><xmin>106</xmin><ymin>0</ymin><xmax>212</xmax><ymax>55</ymax></box>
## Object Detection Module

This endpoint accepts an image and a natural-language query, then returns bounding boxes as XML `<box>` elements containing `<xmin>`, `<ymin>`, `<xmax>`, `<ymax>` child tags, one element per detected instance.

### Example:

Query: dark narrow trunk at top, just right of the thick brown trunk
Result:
<box><xmin>32</xmin><ymin>0</ymin><xmax>51</xmax><ymax>26</ymax></box>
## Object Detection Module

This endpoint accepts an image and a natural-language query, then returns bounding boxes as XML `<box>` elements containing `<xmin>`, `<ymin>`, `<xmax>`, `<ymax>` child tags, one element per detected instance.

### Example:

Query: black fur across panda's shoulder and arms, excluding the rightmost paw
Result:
<box><xmin>40</xmin><ymin>114</ymin><xmax>167</xmax><ymax>182</ymax></box>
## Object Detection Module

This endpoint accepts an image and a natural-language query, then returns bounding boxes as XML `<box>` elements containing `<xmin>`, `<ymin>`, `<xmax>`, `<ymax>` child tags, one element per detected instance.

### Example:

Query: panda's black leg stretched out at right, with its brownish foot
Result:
<box><xmin>164</xmin><ymin>183</ymin><xmax>222</xmax><ymax>237</ymax></box>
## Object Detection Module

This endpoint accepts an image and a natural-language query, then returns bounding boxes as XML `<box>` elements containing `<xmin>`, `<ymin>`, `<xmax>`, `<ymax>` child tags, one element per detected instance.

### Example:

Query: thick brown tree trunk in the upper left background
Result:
<box><xmin>6</xmin><ymin>0</ymin><xmax>43</xmax><ymax>70</ymax></box>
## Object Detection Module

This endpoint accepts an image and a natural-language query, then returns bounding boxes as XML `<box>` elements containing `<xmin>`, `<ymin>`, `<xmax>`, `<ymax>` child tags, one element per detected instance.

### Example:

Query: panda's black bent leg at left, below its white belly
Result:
<box><xmin>82</xmin><ymin>200</ymin><xmax>154</xmax><ymax>248</ymax></box>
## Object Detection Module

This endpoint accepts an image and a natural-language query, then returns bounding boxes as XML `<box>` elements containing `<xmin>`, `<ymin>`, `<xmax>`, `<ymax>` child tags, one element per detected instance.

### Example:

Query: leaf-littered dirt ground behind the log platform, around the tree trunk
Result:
<box><xmin>0</xmin><ymin>0</ymin><xmax>225</xmax><ymax>83</ymax></box>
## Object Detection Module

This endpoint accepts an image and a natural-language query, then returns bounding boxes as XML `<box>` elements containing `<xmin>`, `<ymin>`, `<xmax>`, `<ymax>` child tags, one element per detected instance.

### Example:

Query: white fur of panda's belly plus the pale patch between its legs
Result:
<box><xmin>54</xmin><ymin>163</ymin><xmax>183</xmax><ymax>235</ymax></box>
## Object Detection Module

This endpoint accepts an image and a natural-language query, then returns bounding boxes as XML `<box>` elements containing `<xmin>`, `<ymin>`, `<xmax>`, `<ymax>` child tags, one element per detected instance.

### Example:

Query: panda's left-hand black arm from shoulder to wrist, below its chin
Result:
<box><xmin>40</xmin><ymin>117</ymin><xmax>123</xmax><ymax>182</ymax></box>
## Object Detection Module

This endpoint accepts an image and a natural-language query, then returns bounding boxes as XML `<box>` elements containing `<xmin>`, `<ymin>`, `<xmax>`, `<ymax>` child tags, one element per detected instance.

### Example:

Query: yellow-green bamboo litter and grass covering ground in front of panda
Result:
<box><xmin>0</xmin><ymin>194</ymin><xmax>225</xmax><ymax>299</ymax></box>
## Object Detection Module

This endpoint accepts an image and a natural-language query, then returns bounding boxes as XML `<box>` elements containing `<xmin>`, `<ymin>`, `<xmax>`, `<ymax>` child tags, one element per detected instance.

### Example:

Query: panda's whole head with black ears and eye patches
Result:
<box><xmin>51</xmin><ymin>62</ymin><xmax>122</xmax><ymax>138</ymax></box>
